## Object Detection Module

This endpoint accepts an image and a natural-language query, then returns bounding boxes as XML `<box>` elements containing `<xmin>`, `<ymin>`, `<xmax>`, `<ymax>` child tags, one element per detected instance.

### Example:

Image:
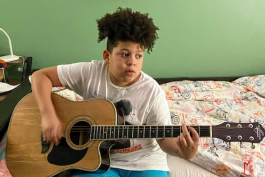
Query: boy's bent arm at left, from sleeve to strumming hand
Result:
<box><xmin>31</xmin><ymin>66</ymin><xmax>62</xmax><ymax>144</ymax></box>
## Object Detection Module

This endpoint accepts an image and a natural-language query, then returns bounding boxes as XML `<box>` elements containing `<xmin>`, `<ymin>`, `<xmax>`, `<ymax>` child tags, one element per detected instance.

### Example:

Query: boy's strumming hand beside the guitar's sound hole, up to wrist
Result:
<box><xmin>41</xmin><ymin>116</ymin><xmax>62</xmax><ymax>145</ymax></box>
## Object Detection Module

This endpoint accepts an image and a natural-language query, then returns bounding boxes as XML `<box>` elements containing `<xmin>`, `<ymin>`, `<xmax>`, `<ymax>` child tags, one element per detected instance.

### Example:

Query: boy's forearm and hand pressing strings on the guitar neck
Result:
<box><xmin>157</xmin><ymin>123</ymin><xmax>199</xmax><ymax>159</ymax></box>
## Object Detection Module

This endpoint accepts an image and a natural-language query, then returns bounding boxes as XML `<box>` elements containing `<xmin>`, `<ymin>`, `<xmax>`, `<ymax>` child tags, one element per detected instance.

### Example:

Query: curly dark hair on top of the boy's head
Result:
<box><xmin>97</xmin><ymin>7</ymin><xmax>159</xmax><ymax>53</ymax></box>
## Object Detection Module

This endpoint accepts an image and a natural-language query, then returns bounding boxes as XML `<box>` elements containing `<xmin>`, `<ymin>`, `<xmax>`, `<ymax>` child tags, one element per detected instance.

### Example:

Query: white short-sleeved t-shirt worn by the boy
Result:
<box><xmin>57</xmin><ymin>60</ymin><xmax>171</xmax><ymax>171</ymax></box>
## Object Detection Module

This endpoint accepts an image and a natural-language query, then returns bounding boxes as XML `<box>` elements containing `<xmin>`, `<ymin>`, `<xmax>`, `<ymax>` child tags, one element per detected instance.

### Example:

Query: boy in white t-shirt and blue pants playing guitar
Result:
<box><xmin>32</xmin><ymin>8</ymin><xmax>199</xmax><ymax>177</ymax></box>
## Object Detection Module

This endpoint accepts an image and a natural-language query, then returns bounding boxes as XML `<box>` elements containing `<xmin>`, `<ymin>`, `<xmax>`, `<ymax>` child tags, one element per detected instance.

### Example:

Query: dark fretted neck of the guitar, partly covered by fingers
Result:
<box><xmin>90</xmin><ymin>125</ymin><xmax>212</xmax><ymax>140</ymax></box>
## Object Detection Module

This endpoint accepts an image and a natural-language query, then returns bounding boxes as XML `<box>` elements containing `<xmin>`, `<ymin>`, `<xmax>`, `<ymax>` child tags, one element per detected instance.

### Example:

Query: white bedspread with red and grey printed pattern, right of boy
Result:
<box><xmin>161</xmin><ymin>75</ymin><xmax>265</xmax><ymax>177</ymax></box>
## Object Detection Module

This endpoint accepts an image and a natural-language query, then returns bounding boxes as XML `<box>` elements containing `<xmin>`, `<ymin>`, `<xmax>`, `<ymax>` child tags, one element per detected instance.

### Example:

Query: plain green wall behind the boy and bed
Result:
<box><xmin>0</xmin><ymin>0</ymin><xmax>265</xmax><ymax>77</ymax></box>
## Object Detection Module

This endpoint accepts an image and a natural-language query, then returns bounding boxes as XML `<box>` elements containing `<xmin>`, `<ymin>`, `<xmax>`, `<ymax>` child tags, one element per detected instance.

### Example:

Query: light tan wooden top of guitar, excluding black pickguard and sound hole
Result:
<box><xmin>6</xmin><ymin>93</ymin><xmax>117</xmax><ymax>177</ymax></box>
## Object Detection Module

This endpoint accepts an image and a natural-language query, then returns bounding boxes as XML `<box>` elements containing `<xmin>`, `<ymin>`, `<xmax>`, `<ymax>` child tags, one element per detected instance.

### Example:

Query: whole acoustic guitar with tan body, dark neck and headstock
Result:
<box><xmin>6</xmin><ymin>93</ymin><xmax>264</xmax><ymax>177</ymax></box>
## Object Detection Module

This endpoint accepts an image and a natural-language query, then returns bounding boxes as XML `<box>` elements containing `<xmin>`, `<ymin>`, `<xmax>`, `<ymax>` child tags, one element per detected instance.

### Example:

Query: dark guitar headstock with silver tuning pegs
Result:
<box><xmin>212</xmin><ymin>122</ymin><xmax>265</xmax><ymax>143</ymax></box>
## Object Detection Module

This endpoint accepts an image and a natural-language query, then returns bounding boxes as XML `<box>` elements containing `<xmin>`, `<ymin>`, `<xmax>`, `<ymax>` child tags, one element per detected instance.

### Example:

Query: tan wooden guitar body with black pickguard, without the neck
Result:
<box><xmin>6</xmin><ymin>93</ymin><xmax>117</xmax><ymax>177</ymax></box>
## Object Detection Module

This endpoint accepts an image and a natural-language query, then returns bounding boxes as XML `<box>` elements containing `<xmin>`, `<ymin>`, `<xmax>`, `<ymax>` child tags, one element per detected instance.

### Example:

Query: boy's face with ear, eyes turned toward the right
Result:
<box><xmin>103</xmin><ymin>41</ymin><xmax>144</xmax><ymax>87</ymax></box>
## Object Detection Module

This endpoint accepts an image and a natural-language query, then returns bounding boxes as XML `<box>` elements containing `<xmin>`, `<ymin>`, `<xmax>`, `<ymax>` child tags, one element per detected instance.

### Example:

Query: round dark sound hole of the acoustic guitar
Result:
<box><xmin>70</xmin><ymin>121</ymin><xmax>91</xmax><ymax>145</ymax></box>
